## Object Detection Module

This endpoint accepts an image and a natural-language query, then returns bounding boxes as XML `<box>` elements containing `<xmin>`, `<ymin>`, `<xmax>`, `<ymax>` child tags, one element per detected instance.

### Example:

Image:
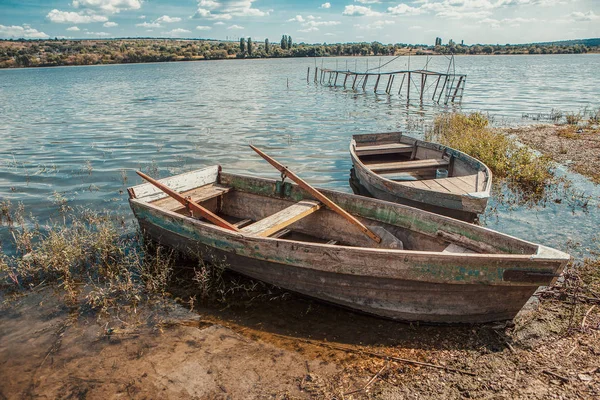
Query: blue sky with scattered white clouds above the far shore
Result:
<box><xmin>0</xmin><ymin>0</ymin><xmax>600</xmax><ymax>44</ymax></box>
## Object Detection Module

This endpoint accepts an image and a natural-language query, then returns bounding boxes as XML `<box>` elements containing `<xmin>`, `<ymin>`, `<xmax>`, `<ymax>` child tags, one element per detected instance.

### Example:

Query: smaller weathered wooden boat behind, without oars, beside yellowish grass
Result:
<box><xmin>350</xmin><ymin>132</ymin><xmax>492</xmax><ymax>222</ymax></box>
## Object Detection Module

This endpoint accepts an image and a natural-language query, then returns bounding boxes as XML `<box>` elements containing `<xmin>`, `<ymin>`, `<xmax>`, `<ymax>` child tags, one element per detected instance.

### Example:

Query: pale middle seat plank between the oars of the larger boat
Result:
<box><xmin>242</xmin><ymin>200</ymin><xmax>322</xmax><ymax>237</ymax></box>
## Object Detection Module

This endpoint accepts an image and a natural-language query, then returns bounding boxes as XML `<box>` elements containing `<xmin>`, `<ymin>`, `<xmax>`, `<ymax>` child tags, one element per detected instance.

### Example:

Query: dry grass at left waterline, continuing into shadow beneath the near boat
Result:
<box><xmin>0</xmin><ymin>202</ymin><xmax>266</xmax><ymax>316</ymax></box>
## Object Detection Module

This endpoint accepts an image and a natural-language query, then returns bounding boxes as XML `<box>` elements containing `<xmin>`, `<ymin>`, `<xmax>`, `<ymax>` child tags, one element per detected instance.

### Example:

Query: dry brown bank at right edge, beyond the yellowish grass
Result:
<box><xmin>502</xmin><ymin>124</ymin><xmax>600</xmax><ymax>184</ymax></box>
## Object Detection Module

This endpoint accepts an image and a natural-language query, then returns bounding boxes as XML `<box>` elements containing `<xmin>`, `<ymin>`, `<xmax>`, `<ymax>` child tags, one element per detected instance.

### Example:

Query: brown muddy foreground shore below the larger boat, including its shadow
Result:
<box><xmin>0</xmin><ymin>270</ymin><xmax>600</xmax><ymax>399</ymax></box>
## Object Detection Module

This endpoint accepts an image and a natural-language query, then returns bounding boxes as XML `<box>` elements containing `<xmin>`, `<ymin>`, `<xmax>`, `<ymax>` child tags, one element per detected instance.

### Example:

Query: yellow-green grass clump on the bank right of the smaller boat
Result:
<box><xmin>427</xmin><ymin>113</ymin><xmax>555</xmax><ymax>201</ymax></box>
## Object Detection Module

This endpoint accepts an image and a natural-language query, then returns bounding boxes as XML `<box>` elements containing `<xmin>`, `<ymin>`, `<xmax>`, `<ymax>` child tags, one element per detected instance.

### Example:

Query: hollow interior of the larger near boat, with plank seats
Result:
<box><xmin>134</xmin><ymin>173</ymin><xmax>537</xmax><ymax>254</ymax></box>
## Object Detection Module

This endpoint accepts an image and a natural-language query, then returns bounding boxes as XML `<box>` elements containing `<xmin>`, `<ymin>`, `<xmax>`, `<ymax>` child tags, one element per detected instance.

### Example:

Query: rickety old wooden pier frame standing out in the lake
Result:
<box><xmin>307</xmin><ymin>67</ymin><xmax>467</xmax><ymax>104</ymax></box>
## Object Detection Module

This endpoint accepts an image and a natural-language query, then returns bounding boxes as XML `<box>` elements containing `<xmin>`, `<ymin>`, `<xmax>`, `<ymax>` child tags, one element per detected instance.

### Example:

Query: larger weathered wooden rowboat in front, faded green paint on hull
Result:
<box><xmin>129</xmin><ymin>166</ymin><xmax>569</xmax><ymax>323</ymax></box>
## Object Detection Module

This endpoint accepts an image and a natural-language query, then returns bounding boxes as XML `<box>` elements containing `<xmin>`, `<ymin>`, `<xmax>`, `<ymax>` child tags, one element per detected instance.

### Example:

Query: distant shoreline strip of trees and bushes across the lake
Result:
<box><xmin>0</xmin><ymin>35</ymin><xmax>600</xmax><ymax>68</ymax></box>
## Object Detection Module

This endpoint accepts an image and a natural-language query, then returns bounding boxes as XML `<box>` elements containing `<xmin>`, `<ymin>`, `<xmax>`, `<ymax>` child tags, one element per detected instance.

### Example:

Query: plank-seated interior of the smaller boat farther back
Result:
<box><xmin>353</xmin><ymin>134</ymin><xmax>487</xmax><ymax>194</ymax></box>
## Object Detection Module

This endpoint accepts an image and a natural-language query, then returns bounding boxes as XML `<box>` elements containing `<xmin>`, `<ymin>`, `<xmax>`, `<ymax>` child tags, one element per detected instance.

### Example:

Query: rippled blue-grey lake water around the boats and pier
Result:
<box><xmin>0</xmin><ymin>55</ymin><xmax>600</xmax><ymax>256</ymax></box>
